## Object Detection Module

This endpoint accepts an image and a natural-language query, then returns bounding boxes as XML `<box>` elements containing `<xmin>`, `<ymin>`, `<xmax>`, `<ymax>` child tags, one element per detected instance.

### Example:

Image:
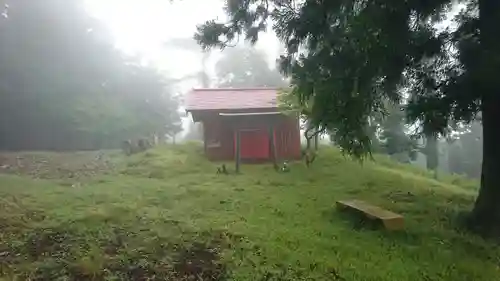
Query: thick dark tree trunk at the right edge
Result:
<box><xmin>470</xmin><ymin>0</ymin><xmax>500</xmax><ymax>235</ymax></box>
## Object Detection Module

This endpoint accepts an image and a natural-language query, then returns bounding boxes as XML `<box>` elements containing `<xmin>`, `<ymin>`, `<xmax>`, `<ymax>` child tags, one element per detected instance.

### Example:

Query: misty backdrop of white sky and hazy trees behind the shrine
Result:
<box><xmin>0</xmin><ymin>0</ymin><xmax>482</xmax><ymax>178</ymax></box>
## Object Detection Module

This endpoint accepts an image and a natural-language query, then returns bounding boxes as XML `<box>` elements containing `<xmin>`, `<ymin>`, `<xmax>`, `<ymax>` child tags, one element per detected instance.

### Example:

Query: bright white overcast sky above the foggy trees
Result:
<box><xmin>86</xmin><ymin>0</ymin><xmax>278</xmax><ymax>85</ymax></box>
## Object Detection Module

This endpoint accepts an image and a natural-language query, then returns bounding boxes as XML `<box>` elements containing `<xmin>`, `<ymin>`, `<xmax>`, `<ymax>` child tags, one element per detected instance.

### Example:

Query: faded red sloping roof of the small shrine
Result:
<box><xmin>185</xmin><ymin>88</ymin><xmax>278</xmax><ymax>111</ymax></box>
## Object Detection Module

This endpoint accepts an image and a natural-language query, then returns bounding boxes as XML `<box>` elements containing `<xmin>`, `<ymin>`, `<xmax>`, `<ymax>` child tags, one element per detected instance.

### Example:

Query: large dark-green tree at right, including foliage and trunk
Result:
<box><xmin>196</xmin><ymin>0</ymin><xmax>500</xmax><ymax>230</ymax></box>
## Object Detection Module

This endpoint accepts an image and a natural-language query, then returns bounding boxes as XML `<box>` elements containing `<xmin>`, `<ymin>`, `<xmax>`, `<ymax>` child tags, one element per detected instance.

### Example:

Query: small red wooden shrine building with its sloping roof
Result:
<box><xmin>186</xmin><ymin>88</ymin><xmax>301</xmax><ymax>162</ymax></box>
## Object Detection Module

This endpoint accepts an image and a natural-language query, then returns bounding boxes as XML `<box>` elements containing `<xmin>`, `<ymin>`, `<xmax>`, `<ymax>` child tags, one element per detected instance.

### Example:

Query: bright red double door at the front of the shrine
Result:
<box><xmin>235</xmin><ymin>129</ymin><xmax>269</xmax><ymax>160</ymax></box>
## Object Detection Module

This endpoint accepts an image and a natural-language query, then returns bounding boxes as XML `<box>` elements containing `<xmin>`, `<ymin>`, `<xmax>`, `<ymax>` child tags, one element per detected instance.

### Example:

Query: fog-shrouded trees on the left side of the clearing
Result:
<box><xmin>0</xmin><ymin>0</ymin><xmax>181</xmax><ymax>150</ymax></box>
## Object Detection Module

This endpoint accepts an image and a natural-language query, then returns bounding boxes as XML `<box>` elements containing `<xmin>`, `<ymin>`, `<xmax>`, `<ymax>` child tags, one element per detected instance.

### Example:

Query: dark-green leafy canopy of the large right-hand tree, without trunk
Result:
<box><xmin>195</xmin><ymin>0</ymin><xmax>480</xmax><ymax>157</ymax></box>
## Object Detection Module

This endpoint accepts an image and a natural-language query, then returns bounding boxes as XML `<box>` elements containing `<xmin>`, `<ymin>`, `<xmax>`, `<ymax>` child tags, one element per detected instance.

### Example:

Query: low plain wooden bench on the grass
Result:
<box><xmin>337</xmin><ymin>200</ymin><xmax>404</xmax><ymax>230</ymax></box>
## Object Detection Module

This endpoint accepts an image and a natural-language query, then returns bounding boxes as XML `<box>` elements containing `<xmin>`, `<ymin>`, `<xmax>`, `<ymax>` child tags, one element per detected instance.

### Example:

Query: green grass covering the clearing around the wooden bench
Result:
<box><xmin>0</xmin><ymin>145</ymin><xmax>500</xmax><ymax>281</ymax></box>
